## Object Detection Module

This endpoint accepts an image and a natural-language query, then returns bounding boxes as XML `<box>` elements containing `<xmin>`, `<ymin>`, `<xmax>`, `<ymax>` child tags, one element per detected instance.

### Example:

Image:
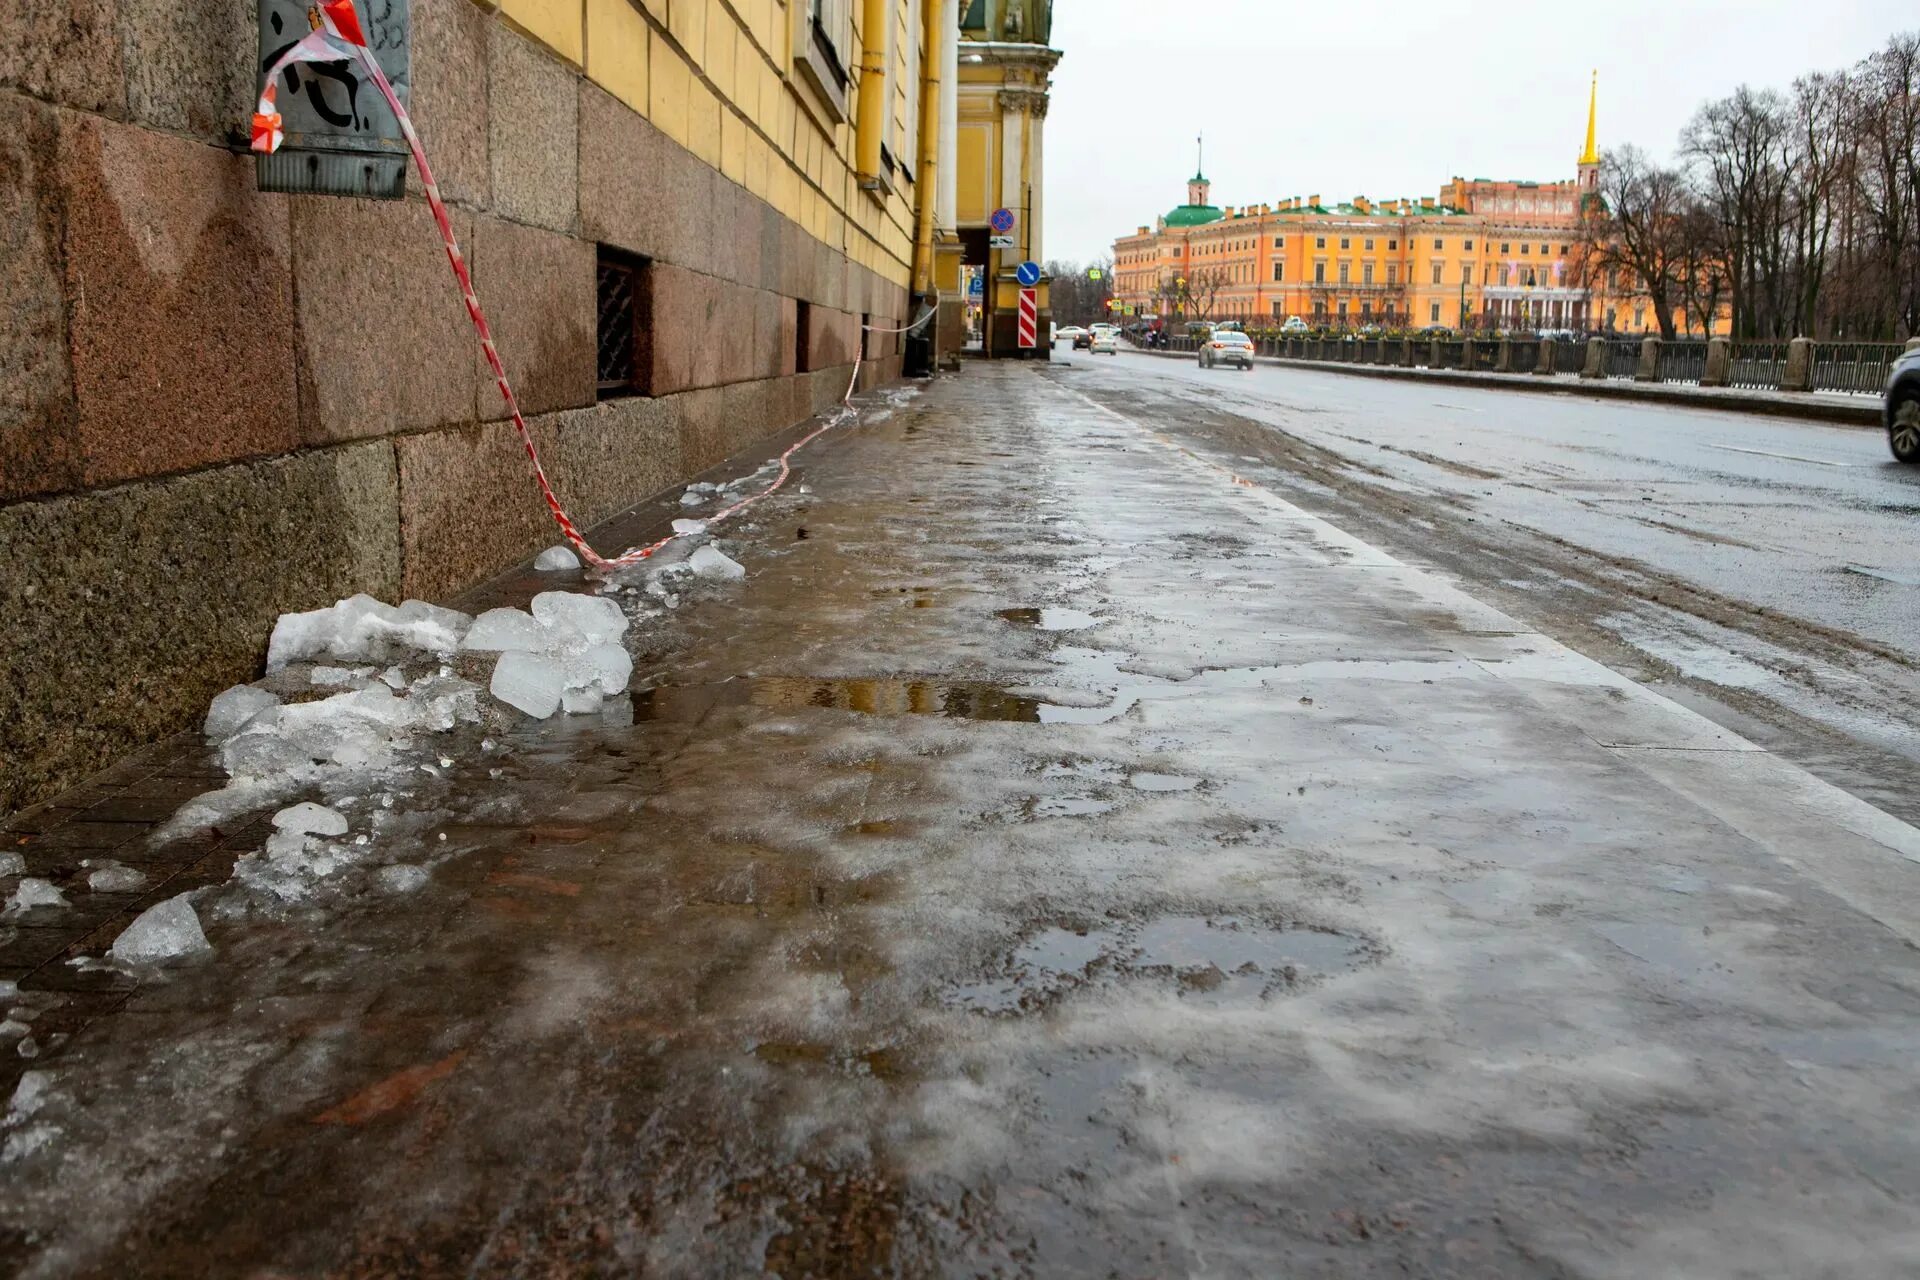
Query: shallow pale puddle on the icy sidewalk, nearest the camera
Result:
<box><xmin>943</xmin><ymin>915</ymin><xmax>1375</xmax><ymax>1015</ymax></box>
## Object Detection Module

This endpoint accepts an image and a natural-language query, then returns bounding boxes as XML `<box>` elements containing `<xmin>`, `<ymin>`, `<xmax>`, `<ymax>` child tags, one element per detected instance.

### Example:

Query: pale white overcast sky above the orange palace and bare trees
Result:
<box><xmin>1044</xmin><ymin>0</ymin><xmax>1920</xmax><ymax>261</ymax></box>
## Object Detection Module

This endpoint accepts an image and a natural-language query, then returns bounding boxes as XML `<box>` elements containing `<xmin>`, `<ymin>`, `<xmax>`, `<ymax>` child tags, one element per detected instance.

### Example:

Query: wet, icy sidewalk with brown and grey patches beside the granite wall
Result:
<box><xmin>0</xmin><ymin>365</ymin><xmax>1920</xmax><ymax>1278</ymax></box>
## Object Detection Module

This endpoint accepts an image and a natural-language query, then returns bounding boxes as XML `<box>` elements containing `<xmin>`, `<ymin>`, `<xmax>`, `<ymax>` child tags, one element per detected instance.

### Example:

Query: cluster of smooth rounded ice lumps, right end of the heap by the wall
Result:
<box><xmin>463</xmin><ymin>591</ymin><xmax>634</xmax><ymax>720</ymax></box>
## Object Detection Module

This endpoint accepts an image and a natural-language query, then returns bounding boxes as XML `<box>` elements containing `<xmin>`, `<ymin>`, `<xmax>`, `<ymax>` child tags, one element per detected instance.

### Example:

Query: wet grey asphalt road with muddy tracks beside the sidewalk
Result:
<box><xmin>1056</xmin><ymin>349</ymin><xmax>1920</xmax><ymax>821</ymax></box>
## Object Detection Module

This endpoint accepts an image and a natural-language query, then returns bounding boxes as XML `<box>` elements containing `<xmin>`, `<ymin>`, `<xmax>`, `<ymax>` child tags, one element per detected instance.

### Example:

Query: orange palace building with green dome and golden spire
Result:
<box><xmin>1114</xmin><ymin>81</ymin><xmax>1651</xmax><ymax>330</ymax></box>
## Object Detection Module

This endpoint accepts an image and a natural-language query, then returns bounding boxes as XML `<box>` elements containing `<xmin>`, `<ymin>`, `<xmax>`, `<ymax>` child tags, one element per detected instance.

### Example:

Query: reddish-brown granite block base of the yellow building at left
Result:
<box><xmin>0</xmin><ymin>0</ymin><xmax>910</xmax><ymax>814</ymax></box>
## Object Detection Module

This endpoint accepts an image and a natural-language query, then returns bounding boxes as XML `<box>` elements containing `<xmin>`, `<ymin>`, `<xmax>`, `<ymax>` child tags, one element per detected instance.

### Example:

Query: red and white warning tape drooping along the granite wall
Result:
<box><xmin>252</xmin><ymin>0</ymin><xmax>933</xmax><ymax>570</ymax></box>
